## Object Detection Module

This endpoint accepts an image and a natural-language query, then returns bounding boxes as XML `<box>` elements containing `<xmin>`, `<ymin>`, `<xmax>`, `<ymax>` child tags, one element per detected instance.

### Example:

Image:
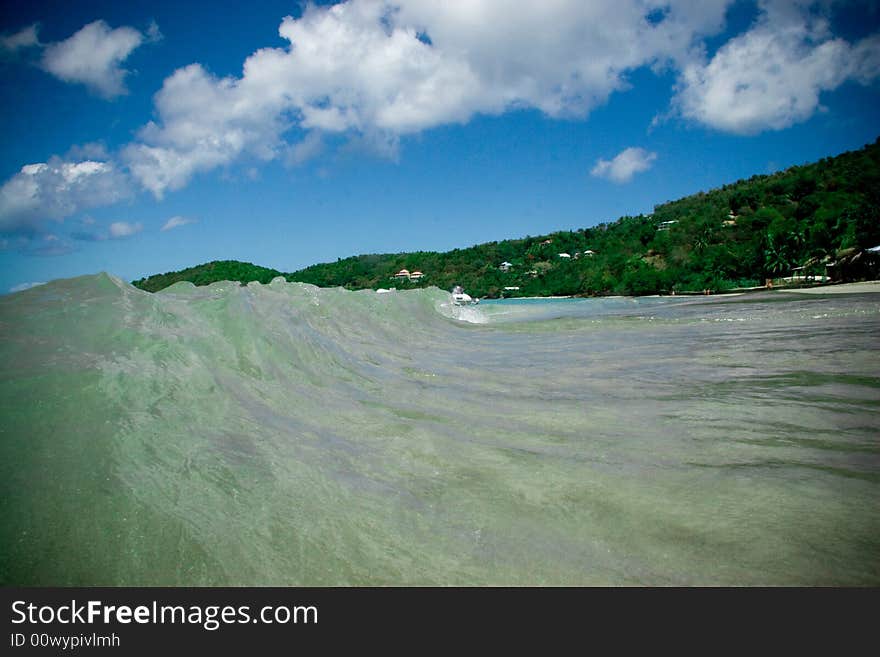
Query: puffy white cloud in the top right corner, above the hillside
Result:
<box><xmin>674</xmin><ymin>1</ymin><xmax>880</xmax><ymax>135</ymax></box>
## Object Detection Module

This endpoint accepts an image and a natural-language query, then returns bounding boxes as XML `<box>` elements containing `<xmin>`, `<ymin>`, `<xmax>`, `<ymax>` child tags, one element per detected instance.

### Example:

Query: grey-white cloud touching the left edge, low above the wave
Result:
<box><xmin>0</xmin><ymin>157</ymin><xmax>131</xmax><ymax>235</ymax></box>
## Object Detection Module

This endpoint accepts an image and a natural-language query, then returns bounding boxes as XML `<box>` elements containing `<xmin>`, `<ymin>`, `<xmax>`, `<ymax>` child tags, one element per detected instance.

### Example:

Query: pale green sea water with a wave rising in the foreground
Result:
<box><xmin>0</xmin><ymin>274</ymin><xmax>880</xmax><ymax>585</ymax></box>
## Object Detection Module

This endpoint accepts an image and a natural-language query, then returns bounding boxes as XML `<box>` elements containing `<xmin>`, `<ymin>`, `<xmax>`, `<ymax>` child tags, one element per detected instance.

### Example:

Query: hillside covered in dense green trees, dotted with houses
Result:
<box><xmin>135</xmin><ymin>139</ymin><xmax>880</xmax><ymax>297</ymax></box>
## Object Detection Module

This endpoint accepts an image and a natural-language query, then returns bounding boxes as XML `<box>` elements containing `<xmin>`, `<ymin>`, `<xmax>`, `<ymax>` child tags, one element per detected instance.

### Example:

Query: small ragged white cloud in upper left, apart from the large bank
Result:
<box><xmin>42</xmin><ymin>20</ymin><xmax>147</xmax><ymax>98</ymax></box>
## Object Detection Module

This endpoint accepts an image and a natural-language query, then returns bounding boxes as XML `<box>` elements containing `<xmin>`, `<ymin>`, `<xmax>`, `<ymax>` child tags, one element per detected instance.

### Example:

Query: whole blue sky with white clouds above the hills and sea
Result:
<box><xmin>0</xmin><ymin>0</ymin><xmax>880</xmax><ymax>292</ymax></box>
